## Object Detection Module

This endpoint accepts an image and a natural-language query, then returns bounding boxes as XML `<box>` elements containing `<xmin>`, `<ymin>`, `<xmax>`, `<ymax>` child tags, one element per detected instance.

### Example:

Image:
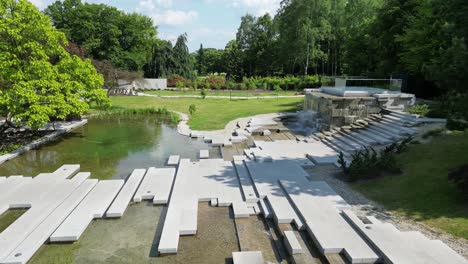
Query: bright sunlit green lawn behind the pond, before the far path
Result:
<box><xmin>111</xmin><ymin>96</ymin><xmax>303</xmax><ymax>130</ymax></box>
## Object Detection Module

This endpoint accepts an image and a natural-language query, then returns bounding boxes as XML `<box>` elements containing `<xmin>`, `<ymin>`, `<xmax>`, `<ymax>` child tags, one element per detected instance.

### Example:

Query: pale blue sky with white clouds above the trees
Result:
<box><xmin>30</xmin><ymin>0</ymin><xmax>281</xmax><ymax>52</ymax></box>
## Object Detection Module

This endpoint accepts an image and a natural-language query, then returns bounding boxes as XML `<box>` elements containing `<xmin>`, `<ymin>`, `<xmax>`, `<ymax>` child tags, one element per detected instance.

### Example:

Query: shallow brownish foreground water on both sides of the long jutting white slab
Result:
<box><xmin>30</xmin><ymin>203</ymin><xmax>239</xmax><ymax>264</ymax></box>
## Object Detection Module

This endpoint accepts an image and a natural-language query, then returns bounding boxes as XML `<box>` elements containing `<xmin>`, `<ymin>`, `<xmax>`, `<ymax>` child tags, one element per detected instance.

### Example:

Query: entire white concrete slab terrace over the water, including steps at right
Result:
<box><xmin>0</xmin><ymin>112</ymin><xmax>468</xmax><ymax>263</ymax></box>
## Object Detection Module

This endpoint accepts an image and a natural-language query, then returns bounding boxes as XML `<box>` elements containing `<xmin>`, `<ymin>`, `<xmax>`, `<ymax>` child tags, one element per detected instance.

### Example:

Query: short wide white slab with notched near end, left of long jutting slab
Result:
<box><xmin>133</xmin><ymin>168</ymin><xmax>176</xmax><ymax>204</ymax></box>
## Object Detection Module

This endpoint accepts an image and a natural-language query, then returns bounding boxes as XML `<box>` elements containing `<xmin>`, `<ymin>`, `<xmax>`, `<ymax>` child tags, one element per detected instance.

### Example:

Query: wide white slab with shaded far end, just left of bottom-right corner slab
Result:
<box><xmin>280</xmin><ymin>178</ymin><xmax>379</xmax><ymax>263</ymax></box>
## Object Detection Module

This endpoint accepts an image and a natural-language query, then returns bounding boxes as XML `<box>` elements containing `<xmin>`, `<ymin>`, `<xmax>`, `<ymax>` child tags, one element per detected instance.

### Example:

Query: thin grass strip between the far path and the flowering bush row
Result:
<box><xmin>143</xmin><ymin>90</ymin><xmax>297</xmax><ymax>97</ymax></box>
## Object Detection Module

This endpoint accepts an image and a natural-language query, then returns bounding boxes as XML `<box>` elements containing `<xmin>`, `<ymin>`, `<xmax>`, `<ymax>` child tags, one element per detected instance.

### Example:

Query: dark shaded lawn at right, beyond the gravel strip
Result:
<box><xmin>354</xmin><ymin>132</ymin><xmax>468</xmax><ymax>239</ymax></box>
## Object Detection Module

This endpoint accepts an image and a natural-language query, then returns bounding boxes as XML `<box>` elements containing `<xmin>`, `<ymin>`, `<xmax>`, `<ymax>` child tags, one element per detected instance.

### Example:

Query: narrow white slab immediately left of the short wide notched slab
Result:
<box><xmin>106</xmin><ymin>169</ymin><xmax>146</xmax><ymax>218</ymax></box>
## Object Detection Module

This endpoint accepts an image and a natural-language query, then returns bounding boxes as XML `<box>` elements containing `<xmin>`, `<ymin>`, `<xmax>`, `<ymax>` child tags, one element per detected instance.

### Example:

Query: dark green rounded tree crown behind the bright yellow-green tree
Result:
<box><xmin>44</xmin><ymin>0</ymin><xmax>157</xmax><ymax>71</ymax></box>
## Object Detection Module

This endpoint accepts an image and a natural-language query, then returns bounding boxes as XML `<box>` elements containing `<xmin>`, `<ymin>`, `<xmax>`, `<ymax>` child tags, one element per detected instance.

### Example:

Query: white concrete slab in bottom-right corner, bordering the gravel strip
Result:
<box><xmin>343</xmin><ymin>210</ymin><xmax>468</xmax><ymax>264</ymax></box>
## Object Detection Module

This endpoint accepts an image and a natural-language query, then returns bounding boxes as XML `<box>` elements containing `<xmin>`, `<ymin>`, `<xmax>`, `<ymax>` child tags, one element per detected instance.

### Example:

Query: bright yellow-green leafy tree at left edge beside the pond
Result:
<box><xmin>0</xmin><ymin>0</ymin><xmax>109</xmax><ymax>129</ymax></box>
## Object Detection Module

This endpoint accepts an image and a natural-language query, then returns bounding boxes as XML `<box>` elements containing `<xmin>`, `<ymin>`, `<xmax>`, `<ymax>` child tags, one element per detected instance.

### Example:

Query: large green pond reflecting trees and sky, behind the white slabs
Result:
<box><xmin>0</xmin><ymin>116</ymin><xmax>208</xmax><ymax>179</ymax></box>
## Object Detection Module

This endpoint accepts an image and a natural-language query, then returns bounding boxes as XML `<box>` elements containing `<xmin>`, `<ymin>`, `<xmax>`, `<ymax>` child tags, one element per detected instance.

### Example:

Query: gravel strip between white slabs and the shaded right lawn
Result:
<box><xmin>304</xmin><ymin>165</ymin><xmax>468</xmax><ymax>260</ymax></box>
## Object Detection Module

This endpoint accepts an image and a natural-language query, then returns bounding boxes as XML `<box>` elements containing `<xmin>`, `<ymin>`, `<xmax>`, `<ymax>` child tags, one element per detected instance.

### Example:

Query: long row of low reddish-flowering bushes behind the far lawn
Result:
<box><xmin>167</xmin><ymin>75</ymin><xmax>321</xmax><ymax>91</ymax></box>
